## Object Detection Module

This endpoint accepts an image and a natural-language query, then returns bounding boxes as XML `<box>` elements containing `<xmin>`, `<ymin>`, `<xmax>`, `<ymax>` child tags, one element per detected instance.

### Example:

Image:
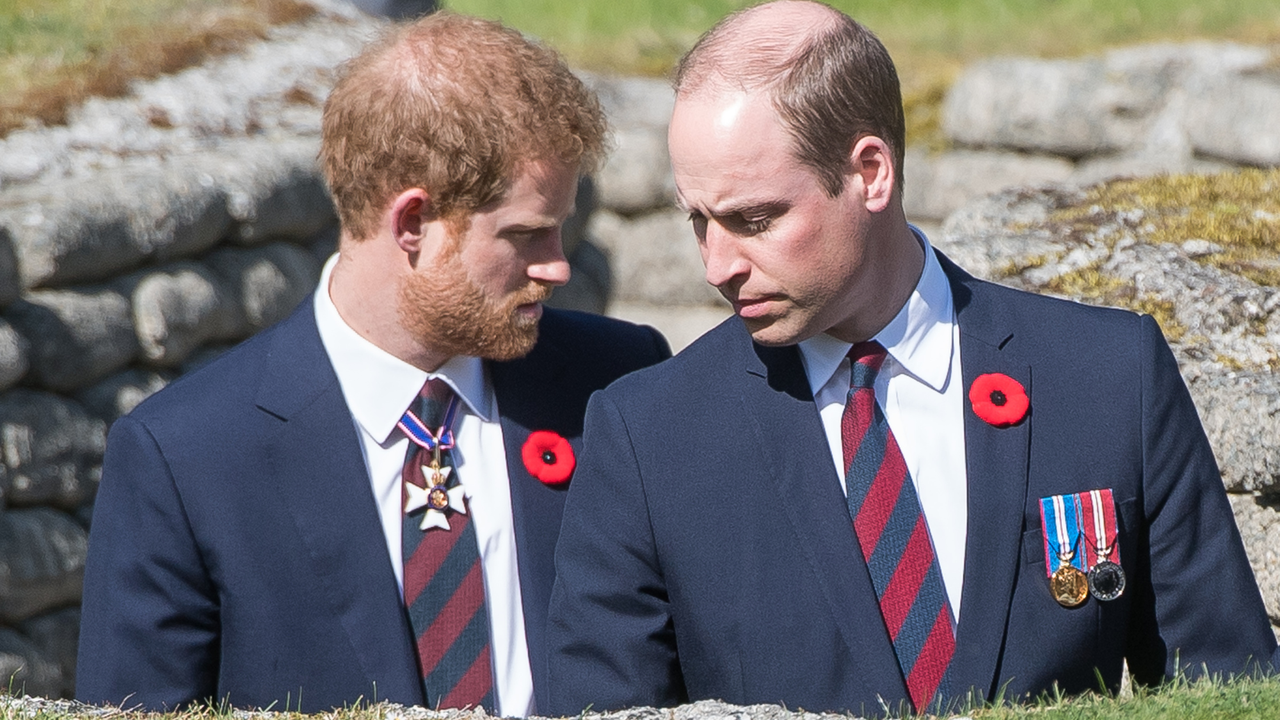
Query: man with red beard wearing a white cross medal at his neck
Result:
<box><xmin>77</xmin><ymin>14</ymin><xmax>669</xmax><ymax>717</ymax></box>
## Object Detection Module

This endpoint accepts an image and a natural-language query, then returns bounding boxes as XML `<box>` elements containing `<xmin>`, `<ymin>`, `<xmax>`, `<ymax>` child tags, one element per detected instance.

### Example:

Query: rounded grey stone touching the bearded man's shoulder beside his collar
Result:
<box><xmin>206</xmin><ymin>242</ymin><xmax>320</xmax><ymax>334</ymax></box>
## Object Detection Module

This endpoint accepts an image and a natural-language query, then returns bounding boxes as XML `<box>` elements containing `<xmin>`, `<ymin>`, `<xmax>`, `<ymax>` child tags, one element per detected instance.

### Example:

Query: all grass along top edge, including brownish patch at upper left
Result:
<box><xmin>0</xmin><ymin>0</ymin><xmax>1280</xmax><ymax>145</ymax></box>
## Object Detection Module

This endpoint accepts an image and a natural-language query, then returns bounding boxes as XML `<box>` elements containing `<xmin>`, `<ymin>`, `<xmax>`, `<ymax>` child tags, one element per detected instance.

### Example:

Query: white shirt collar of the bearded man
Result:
<box><xmin>315</xmin><ymin>254</ymin><xmax>494</xmax><ymax>443</ymax></box>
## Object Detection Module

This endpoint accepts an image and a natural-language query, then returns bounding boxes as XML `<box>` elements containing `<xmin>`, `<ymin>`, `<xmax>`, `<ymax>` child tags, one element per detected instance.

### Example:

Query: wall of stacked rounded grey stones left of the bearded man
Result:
<box><xmin>0</xmin><ymin>1</ymin><xmax>376</xmax><ymax>696</ymax></box>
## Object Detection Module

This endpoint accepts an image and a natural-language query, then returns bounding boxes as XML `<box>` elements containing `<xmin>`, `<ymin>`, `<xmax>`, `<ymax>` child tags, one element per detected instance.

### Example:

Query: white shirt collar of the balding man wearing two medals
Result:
<box><xmin>800</xmin><ymin>227</ymin><xmax>955</xmax><ymax>396</ymax></box>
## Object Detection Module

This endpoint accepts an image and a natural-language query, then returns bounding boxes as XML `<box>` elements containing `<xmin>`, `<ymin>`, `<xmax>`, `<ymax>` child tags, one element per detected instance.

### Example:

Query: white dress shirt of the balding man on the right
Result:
<box><xmin>800</xmin><ymin>228</ymin><xmax>969</xmax><ymax>623</ymax></box>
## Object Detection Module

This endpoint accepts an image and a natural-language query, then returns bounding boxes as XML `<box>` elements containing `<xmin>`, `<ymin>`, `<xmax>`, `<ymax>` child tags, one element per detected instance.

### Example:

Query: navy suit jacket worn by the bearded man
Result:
<box><xmin>77</xmin><ymin>301</ymin><xmax>671</xmax><ymax>712</ymax></box>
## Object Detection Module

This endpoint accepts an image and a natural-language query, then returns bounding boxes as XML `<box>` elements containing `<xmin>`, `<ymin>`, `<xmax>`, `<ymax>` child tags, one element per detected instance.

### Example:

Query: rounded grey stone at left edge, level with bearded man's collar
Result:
<box><xmin>8</xmin><ymin>288</ymin><xmax>138</xmax><ymax>391</ymax></box>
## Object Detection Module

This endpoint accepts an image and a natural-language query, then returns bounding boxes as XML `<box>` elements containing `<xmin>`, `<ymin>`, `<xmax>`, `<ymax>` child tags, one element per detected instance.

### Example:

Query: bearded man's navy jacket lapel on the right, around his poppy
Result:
<box><xmin>488</xmin><ymin>334</ymin><xmax>570</xmax><ymax>707</ymax></box>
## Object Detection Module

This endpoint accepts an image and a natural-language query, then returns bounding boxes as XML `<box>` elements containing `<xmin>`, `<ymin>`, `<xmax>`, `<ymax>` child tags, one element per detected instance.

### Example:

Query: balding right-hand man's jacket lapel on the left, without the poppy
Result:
<box><xmin>742</xmin><ymin>328</ymin><xmax>908</xmax><ymax>703</ymax></box>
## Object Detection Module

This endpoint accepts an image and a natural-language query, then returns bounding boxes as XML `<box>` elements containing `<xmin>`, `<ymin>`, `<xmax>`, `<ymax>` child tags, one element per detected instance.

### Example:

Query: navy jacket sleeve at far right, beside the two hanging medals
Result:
<box><xmin>1126</xmin><ymin>316</ymin><xmax>1276</xmax><ymax>683</ymax></box>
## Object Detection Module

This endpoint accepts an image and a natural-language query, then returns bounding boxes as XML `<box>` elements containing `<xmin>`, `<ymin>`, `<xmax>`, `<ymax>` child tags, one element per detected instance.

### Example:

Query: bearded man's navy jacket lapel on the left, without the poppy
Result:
<box><xmin>257</xmin><ymin>300</ymin><xmax>422</xmax><ymax>702</ymax></box>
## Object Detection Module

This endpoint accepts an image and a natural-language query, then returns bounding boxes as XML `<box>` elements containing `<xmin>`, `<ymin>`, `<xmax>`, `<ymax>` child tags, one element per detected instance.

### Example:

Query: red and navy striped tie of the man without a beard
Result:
<box><xmin>841</xmin><ymin>341</ymin><xmax>955</xmax><ymax>712</ymax></box>
